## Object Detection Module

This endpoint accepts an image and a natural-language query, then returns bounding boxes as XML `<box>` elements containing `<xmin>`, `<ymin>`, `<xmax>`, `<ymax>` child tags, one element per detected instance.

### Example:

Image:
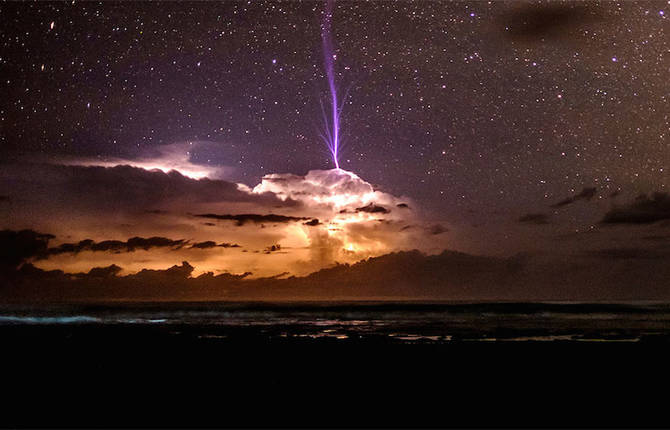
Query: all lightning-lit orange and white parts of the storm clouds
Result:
<box><xmin>25</xmin><ymin>162</ymin><xmax>446</xmax><ymax>277</ymax></box>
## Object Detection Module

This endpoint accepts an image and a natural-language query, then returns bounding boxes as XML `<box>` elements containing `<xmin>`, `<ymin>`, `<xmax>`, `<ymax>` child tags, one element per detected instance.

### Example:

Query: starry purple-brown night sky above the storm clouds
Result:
<box><xmin>0</xmin><ymin>1</ymin><xmax>670</xmax><ymax>302</ymax></box>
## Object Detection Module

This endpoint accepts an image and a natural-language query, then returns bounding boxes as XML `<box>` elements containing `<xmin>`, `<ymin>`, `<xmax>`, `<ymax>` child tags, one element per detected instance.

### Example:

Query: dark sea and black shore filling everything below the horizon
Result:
<box><xmin>0</xmin><ymin>305</ymin><xmax>670</xmax><ymax>427</ymax></box>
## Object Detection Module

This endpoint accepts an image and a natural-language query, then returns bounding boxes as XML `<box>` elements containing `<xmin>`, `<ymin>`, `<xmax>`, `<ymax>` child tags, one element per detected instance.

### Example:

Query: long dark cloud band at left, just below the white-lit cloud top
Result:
<box><xmin>0</xmin><ymin>163</ymin><xmax>296</xmax><ymax>214</ymax></box>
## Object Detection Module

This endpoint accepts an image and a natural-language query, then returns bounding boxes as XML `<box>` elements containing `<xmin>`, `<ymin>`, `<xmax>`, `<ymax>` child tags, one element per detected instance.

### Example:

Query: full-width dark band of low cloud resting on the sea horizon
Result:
<box><xmin>6</xmin><ymin>242</ymin><xmax>670</xmax><ymax>302</ymax></box>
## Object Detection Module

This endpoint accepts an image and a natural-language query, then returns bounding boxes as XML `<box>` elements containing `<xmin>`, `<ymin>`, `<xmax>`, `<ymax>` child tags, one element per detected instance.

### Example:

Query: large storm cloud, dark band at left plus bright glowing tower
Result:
<box><xmin>0</xmin><ymin>163</ymin><xmax>447</xmax><ymax>276</ymax></box>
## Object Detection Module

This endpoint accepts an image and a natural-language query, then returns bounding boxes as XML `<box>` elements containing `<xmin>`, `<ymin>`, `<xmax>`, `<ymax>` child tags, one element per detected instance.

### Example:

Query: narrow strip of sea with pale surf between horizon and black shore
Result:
<box><xmin>0</xmin><ymin>303</ymin><xmax>670</xmax><ymax>343</ymax></box>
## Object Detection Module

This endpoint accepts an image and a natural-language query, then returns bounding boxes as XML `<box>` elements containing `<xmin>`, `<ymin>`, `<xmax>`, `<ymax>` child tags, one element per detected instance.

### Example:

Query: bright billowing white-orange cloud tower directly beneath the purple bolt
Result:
<box><xmin>251</xmin><ymin>169</ymin><xmax>435</xmax><ymax>265</ymax></box>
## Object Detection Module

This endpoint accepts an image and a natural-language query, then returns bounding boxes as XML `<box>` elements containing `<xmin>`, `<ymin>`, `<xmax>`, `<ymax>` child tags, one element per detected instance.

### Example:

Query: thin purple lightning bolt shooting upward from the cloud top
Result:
<box><xmin>321</xmin><ymin>0</ymin><xmax>346</xmax><ymax>169</ymax></box>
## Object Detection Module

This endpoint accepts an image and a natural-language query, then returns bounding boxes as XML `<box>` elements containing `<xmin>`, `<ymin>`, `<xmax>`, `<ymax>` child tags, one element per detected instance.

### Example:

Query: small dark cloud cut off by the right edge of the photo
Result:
<box><xmin>601</xmin><ymin>192</ymin><xmax>670</xmax><ymax>224</ymax></box>
